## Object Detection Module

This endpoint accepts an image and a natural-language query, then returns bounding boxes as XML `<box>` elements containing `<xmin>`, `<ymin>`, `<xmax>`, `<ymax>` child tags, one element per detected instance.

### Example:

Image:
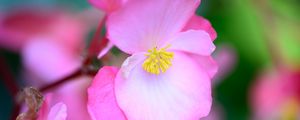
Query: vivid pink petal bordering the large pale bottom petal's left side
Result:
<box><xmin>87</xmin><ymin>67</ymin><xmax>126</xmax><ymax>120</ymax></box>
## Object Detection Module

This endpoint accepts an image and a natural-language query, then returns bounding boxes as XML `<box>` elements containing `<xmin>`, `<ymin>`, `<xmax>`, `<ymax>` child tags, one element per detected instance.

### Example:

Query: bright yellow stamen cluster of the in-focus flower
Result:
<box><xmin>143</xmin><ymin>45</ymin><xmax>174</xmax><ymax>75</ymax></box>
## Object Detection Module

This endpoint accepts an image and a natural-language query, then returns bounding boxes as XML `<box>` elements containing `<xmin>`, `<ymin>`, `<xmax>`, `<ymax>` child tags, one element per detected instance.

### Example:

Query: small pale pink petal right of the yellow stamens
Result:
<box><xmin>170</xmin><ymin>30</ymin><xmax>215</xmax><ymax>56</ymax></box>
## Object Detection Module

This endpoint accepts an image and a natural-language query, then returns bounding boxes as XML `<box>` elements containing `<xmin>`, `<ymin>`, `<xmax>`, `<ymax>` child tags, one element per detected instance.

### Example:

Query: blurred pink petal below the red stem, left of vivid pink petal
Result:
<box><xmin>46</xmin><ymin>76</ymin><xmax>92</xmax><ymax>120</ymax></box>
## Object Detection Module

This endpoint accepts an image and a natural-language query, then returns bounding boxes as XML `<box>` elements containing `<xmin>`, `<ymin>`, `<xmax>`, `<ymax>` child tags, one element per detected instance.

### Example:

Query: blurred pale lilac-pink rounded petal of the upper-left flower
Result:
<box><xmin>22</xmin><ymin>38</ymin><xmax>81</xmax><ymax>84</ymax></box>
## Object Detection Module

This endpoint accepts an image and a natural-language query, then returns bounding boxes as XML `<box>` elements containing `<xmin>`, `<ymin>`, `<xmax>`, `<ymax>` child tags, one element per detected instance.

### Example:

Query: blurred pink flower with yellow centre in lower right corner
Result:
<box><xmin>250</xmin><ymin>70</ymin><xmax>300</xmax><ymax>120</ymax></box>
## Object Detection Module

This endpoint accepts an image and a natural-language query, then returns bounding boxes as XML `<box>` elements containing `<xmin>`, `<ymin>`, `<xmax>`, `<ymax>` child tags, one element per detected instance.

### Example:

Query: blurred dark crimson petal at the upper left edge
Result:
<box><xmin>0</xmin><ymin>10</ymin><xmax>54</xmax><ymax>52</ymax></box>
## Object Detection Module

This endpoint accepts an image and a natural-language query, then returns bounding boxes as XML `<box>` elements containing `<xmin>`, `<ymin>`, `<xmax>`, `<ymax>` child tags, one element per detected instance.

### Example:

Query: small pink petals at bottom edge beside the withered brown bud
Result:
<box><xmin>37</xmin><ymin>94</ymin><xmax>68</xmax><ymax>120</ymax></box>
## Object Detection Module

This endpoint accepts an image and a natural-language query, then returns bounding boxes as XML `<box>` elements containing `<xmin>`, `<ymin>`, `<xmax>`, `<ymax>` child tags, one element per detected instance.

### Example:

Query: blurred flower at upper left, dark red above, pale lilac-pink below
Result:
<box><xmin>0</xmin><ymin>9</ymin><xmax>90</xmax><ymax>87</ymax></box>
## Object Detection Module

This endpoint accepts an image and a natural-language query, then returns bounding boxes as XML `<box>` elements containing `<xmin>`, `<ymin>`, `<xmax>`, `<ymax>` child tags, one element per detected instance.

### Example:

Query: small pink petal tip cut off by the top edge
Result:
<box><xmin>89</xmin><ymin>0</ymin><xmax>127</xmax><ymax>13</ymax></box>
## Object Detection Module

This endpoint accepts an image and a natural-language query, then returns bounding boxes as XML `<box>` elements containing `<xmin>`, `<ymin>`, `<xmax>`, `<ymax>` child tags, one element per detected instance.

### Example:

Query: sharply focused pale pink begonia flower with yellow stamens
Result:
<box><xmin>107</xmin><ymin>0</ymin><xmax>215</xmax><ymax>119</ymax></box>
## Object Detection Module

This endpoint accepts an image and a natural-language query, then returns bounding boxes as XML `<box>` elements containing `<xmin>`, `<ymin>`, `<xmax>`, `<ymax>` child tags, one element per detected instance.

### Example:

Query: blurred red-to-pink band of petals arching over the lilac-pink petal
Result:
<box><xmin>0</xmin><ymin>9</ymin><xmax>86</xmax><ymax>52</ymax></box>
